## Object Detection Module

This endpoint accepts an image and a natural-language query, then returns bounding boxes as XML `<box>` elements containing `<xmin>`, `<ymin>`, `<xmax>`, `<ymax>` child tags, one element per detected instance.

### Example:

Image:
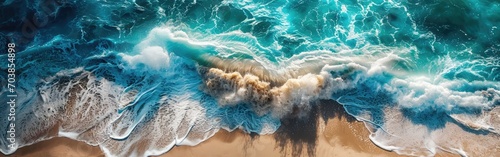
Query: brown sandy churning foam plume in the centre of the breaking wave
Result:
<box><xmin>199</xmin><ymin>67</ymin><xmax>326</xmax><ymax>117</ymax></box>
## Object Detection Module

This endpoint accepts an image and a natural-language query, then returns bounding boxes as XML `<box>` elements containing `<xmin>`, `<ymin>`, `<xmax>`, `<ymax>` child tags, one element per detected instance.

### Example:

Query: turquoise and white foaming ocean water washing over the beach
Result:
<box><xmin>0</xmin><ymin>0</ymin><xmax>500</xmax><ymax>156</ymax></box>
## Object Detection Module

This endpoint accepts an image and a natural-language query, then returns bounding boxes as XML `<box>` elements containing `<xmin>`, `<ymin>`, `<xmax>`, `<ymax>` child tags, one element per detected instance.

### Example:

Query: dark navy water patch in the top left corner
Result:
<box><xmin>0</xmin><ymin>0</ymin><xmax>77</xmax><ymax>51</ymax></box>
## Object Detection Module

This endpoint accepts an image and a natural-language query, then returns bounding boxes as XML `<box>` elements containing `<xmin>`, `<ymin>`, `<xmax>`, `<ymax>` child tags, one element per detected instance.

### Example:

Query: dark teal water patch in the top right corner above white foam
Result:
<box><xmin>408</xmin><ymin>0</ymin><xmax>500</xmax><ymax>56</ymax></box>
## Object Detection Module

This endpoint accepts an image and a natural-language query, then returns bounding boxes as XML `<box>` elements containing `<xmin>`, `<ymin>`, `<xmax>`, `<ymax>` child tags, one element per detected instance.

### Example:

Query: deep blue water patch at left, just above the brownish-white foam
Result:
<box><xmin>0</xmin><ymin>40</ymin><xmax>112</xmax><ymax>89</ymax></box>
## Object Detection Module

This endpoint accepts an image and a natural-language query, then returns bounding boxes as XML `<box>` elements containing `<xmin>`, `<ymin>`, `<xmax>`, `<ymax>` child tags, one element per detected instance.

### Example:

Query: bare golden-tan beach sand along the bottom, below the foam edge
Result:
<box><xmin>0</xmin><ymin>103</ymin><xmax>458</xmax><ymax>157</ymax></box>
